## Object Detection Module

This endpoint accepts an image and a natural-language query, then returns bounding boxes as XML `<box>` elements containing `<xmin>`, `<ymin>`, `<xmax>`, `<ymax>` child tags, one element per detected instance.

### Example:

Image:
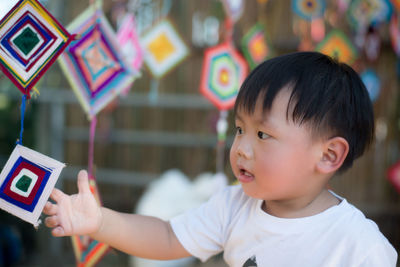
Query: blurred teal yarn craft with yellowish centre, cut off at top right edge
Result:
<box><xmin>347</xmin><ymin>0</ymin><xmax>393</xmax><ymax>29</ymax></box>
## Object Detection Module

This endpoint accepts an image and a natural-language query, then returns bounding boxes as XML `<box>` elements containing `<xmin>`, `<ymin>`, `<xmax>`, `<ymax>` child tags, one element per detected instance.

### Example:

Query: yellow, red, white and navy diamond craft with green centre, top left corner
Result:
<box><xmin>0</xmin><ymin>0</ymin><xmax>72</xmax><ymax>98</ymax></box>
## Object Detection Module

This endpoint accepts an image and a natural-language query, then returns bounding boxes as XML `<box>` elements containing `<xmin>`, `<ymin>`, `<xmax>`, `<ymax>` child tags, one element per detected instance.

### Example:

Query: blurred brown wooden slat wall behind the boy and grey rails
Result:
<box><xmin>0</xmin><ymin>0</ymin><xmax>400</xmax><ymax>265</ymax></box>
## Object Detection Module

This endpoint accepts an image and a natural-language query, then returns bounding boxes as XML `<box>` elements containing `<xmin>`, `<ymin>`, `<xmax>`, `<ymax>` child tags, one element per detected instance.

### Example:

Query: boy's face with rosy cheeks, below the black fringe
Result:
<box><xmin>230</xmin><ymin>89</ymin><xmax>322</xmax><ymax>201</ymax></box>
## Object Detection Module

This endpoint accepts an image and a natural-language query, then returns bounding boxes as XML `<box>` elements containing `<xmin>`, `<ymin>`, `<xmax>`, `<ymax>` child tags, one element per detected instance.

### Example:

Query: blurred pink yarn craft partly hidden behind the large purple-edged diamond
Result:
<box><xmin>117</xmin><ymin>15</ymin><xmax>143</xmax><ymax>74</ymax></box>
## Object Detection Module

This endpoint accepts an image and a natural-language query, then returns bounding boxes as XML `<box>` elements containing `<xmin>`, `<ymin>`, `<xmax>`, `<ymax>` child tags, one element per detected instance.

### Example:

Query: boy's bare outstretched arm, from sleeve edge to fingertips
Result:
<box><xmin>43</xmin><ymin>171</ymin><xmax>190</xmax><ymax>259</ymax></box>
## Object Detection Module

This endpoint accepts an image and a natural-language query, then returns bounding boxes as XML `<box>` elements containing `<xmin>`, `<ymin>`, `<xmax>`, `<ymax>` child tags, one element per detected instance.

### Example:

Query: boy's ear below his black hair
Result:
<box><xmin>317</xmin><ymin>137</ymin><xmax>349</xmax><ymax>174</ymax></box>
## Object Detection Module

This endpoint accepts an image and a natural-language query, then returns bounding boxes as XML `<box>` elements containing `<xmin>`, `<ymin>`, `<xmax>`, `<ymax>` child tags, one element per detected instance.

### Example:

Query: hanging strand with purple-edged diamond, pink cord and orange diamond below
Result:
<box><xmin>59</xmin><ymin>0</ymin><xmax>126</xmax><ymax>267</ymax></box>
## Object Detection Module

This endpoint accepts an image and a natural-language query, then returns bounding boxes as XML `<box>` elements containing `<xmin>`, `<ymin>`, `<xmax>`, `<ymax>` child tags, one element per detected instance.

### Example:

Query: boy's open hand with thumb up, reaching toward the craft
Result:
<box><xmin>43</xmin><ymin>170</ymin><xmax>102</xmax><ymax>236</ymax></box>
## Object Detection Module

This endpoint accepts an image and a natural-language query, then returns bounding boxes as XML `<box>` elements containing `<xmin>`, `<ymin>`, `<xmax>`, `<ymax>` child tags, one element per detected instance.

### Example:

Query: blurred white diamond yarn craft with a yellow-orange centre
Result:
<box><xmin>141</xmin><ymin>20</ymin><xmax>189</xmax><ymax>78</ymax></box>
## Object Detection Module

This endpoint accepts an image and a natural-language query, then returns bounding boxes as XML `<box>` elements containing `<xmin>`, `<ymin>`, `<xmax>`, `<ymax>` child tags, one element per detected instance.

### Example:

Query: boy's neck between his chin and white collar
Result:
<box><xmin>262</xmin><ymin>189</ymin><xmax>340</xmax><ymax>218</ymax></box>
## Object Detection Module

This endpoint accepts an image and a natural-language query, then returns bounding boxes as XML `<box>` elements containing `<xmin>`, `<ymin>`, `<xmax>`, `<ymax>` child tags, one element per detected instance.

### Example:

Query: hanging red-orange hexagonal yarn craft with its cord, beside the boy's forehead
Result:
<box><xmin>200</xmin><ymin>0</ymin><xmax>248</xmax><ymax>174</ymax></box>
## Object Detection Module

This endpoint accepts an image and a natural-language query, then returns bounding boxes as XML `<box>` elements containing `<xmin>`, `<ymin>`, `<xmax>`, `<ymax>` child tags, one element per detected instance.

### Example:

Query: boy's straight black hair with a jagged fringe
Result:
<box><xmin>234</xmin><ymin>52</ymin><xmax>374</xmax><ymax>171</ymax></box>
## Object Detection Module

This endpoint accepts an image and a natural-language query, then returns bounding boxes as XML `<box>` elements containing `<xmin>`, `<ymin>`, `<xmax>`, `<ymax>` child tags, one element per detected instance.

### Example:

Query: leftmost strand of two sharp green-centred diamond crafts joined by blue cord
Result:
<box><xmin>0</xmin><ymin>0</ymin><xmax>69</xmax><ymax>227</ymax></box>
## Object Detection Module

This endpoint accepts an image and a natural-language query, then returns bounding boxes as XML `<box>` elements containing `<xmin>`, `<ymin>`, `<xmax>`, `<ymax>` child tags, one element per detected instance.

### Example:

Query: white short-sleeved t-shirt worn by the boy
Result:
<box><xmin>171</xmin><ymin>185</ymin><xmax>397</xmax><ymax>267</ymax></box>
